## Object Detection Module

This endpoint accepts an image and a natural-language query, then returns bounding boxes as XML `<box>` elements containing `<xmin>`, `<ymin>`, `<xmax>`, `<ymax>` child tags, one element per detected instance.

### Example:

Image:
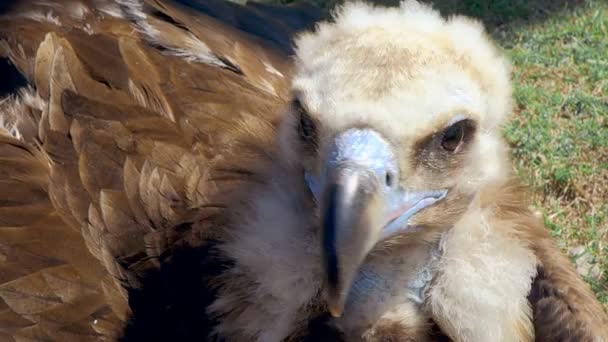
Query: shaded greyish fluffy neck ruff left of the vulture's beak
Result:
<box><xmin>210</xmin><ymin>158</ymin><xmax>322</xmax><ymax>341</ymax></box>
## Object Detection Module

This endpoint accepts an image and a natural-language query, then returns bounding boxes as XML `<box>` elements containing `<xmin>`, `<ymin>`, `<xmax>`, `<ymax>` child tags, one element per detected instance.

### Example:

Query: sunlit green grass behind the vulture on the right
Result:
<box><xmin>258</xmin><ymin>0</ymin><xmax>608</xmax><ymax>308</ymax></box>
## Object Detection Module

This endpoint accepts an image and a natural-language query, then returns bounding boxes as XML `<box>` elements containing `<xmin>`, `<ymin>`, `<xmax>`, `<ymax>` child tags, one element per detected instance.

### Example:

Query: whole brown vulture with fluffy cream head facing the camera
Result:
<box><xmin>0</xmin><ymin>0</ymin><xmax>608</xmax><ymax>342</ymax></box>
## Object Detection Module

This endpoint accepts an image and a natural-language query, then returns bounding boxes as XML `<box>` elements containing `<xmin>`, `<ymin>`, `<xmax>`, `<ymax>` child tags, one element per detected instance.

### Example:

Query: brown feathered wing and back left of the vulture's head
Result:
<box><xmin>0</xmin><ymin>0</ymin><xmax>318</xmax><ymax>341</ymax></box>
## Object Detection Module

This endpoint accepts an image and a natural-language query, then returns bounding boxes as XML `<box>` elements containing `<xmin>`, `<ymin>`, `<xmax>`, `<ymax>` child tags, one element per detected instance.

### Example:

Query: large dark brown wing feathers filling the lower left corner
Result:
<box><xmin>0</xmin><ymin>130</ymin><xmax>117</xmax><ymax>341</ymax></box>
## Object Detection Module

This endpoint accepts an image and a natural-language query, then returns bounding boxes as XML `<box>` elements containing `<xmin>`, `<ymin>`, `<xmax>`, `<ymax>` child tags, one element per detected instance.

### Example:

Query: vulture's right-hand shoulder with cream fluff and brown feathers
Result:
<box><xmin>427</xmin><ymin>179</ymin><xmax>608</xmax><ymax>341</ymax></box>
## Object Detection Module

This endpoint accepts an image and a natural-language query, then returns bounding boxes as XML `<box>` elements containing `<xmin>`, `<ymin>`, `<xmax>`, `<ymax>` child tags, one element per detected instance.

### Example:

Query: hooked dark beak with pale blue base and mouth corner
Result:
<box><xmin>307</xmin><ymin>129</ymin><xmax>447</xmax><ymax>317</ymax></box>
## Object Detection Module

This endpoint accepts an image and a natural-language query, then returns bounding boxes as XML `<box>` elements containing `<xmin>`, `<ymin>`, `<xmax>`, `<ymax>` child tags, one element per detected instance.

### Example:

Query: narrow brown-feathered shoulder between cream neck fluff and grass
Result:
<box><xmin>508</xmin><ymin>188</ymin><xmax>608</xmax><ymax>341</ymax></box>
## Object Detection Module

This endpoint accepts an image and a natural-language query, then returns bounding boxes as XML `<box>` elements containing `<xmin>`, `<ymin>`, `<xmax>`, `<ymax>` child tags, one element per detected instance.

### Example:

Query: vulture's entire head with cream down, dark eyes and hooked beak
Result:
<box><xmin>280</xmin><ymin>2</ymin><xmax>511</xmax><ymax>316</ymax></box>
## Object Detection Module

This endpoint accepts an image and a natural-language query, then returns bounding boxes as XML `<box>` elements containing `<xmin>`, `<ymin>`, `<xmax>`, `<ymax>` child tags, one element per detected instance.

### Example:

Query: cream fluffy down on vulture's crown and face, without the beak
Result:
<box><xmin>281</xmin><ymin>0</ymin><xmax>512</xmax><ymax>214</ymax></box>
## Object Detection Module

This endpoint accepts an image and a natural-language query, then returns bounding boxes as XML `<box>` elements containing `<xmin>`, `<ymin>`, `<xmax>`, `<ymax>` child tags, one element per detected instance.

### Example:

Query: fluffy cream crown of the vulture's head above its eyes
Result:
<box><xmin>294</xmin><ymin>0</ymin><xmax>511</xmax><ymax>130</ymax></box>
